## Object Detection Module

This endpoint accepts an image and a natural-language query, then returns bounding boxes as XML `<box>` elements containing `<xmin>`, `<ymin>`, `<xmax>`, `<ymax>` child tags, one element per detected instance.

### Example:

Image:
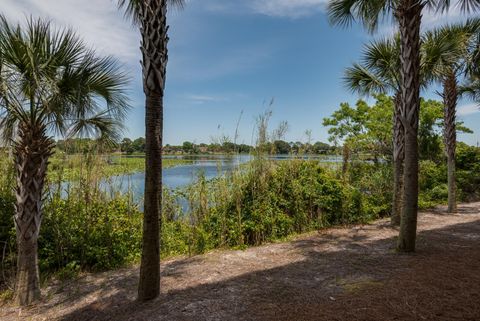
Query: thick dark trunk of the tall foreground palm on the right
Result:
<box><xmin>396</xmin><ymin>0</ymin><xmax>422</xmax><ymax>252</ymax></box>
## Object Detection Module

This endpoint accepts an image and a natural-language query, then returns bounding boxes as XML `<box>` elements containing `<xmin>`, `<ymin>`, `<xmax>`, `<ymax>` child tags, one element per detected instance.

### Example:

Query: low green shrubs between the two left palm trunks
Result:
<box><xmin>39</xmin><ymin>194</ymin><xmax>142</xmax><ymax>273</ymax></box>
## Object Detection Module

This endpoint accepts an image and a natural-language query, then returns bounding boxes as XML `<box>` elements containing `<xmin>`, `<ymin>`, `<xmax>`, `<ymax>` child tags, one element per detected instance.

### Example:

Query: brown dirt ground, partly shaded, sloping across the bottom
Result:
<box><xmin>0</xmin><ymin>203</ymin><xmax>480</xmax><ymax>321</ymax></box>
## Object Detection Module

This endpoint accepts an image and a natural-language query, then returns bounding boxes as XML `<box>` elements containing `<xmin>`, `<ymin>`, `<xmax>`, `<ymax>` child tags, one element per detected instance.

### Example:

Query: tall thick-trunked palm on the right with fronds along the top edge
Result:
<box><xmin>328</xmin><ymin>0</ymin><xmax>480</xmax><ymax>252</ymax></box>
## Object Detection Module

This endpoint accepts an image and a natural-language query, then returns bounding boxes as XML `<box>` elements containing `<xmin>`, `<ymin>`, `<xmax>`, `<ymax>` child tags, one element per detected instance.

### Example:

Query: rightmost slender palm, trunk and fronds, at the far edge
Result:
<box><xmin>424</xmin><ymin>19</ymin><xmax>480</xmax><ymax>213</ymax></box>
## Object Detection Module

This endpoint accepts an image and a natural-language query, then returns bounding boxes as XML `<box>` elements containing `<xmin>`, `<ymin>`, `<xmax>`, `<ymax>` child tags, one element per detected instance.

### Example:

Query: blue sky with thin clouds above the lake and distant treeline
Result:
<box><xmin>0</xmin><ymin>0</ymin><xmax>480</xmax><ymax>144</ymax></box>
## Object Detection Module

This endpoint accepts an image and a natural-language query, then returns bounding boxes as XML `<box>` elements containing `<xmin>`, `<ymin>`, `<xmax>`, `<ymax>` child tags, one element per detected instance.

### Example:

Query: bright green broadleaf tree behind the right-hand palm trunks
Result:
<box><xmin>323</xmin><ymin>94</ymin><xmax>471</xmax><ymax>162</ymax></box>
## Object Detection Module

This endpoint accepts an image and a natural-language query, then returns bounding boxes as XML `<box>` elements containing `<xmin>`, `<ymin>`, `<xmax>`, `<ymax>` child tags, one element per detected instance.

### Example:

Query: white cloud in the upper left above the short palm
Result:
<box><xmin>2</xmin><ymin>0</ymin><xmax>140</xmax><ymax>64</ymax></box>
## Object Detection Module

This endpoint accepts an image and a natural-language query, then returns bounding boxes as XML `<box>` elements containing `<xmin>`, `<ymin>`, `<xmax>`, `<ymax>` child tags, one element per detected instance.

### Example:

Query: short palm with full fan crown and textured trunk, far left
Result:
<box><xmin>0</xmin><ymin>16</ymin><xmax>128</xmax><ymax>305</ymax></box>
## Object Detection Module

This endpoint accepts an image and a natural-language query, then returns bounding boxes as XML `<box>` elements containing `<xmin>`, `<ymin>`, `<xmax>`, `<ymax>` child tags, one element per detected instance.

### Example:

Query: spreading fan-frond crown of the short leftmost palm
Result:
<box><xmin>0</xmin><ymin>16</ymin><xmax>129</xmax><ymax>144</ymax></box>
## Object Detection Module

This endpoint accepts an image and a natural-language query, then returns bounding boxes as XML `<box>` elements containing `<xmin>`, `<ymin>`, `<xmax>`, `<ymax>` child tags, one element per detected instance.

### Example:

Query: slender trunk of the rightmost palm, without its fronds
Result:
<box><xmin>443</xmin><ymin>71</ymin><xmax>458</xmax><ymax>213</ymax></box>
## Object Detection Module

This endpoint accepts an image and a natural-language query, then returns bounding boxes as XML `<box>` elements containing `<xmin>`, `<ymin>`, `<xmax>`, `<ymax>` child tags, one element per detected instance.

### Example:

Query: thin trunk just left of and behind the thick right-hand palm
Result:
<box><xmin>391</xmin><ymin>93</ymin><xmax>405</xmax><ymax>226</ymax></box>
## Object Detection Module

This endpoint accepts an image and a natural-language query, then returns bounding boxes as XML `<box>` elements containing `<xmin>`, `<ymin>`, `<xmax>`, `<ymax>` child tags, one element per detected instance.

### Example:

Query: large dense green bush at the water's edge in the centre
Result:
<box><xmin>162</xmin><ymin>159</ymin><xmax>377</xmax><ymax>255</ymax></box>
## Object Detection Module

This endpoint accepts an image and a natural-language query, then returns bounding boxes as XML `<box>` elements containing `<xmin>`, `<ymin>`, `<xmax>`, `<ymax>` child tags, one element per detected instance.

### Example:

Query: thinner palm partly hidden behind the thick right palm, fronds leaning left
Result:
<box><xmin>344</xmin><ymin>37</ymin><xmax>405</xmax><ymax>226</ymax></box>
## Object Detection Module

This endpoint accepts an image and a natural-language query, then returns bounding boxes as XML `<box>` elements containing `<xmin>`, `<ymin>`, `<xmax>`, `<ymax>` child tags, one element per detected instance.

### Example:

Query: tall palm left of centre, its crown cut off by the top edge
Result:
<box><xmin>118</xmin><ymin>0</ymin><xmax>184</xmax><ymax>301</ymax></box>
